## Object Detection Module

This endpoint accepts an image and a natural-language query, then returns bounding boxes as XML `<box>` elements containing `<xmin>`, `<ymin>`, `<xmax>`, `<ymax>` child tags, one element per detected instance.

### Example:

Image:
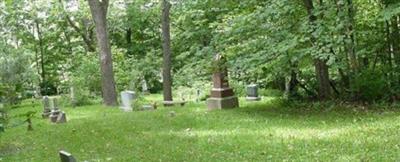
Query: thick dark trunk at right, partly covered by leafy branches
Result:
<box><xmin>303</xmin><ymin>0</ymin><xmax>331</xmax><ymax>100</ymax></box>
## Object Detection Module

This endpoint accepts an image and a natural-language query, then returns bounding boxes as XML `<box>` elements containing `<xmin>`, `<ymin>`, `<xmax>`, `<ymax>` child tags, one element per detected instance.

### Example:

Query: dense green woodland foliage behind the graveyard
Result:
<box><xmin>0</xmin><ymin>0</ymin><xmax>400</xmax><ymax>104</ymax></box>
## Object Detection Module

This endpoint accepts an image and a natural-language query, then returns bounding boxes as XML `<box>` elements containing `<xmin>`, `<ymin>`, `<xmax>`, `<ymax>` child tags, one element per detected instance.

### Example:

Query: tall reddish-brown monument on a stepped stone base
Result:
<box><xmin>207</xmin><ymin>55</ymin><xmax>239</xmax><ymax>110</ymax></box>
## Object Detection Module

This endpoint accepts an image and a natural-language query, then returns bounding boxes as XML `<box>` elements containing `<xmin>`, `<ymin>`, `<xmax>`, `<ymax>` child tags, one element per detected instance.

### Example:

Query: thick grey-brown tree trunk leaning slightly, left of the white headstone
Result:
<box><xmin>88</xmin><ymin>0</ymin><xmax>117</xmax><ymax>106</ymax></box>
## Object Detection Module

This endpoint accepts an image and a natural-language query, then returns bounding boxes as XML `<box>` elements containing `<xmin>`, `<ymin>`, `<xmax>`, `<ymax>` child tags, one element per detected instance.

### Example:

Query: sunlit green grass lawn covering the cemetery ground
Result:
<box><xmin>0</xmin><ymin>96</ymin><xmax>400</xmax><ymax>162</ymax></box>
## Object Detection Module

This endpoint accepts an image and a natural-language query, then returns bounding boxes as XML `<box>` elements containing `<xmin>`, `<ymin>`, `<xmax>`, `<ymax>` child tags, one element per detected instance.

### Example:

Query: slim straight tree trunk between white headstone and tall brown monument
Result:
<box><xmin>162</xmin><ymin>0</ymin><xmax>172</xmax><ymax>101</ymax></box>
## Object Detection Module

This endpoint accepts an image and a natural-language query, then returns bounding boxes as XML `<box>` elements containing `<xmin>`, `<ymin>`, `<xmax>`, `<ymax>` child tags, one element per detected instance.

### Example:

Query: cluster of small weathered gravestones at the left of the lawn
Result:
<box><xmin>42</xmin><ymin>96</ymin><xmax>67</xmax><ymax>123</ymax></box>
